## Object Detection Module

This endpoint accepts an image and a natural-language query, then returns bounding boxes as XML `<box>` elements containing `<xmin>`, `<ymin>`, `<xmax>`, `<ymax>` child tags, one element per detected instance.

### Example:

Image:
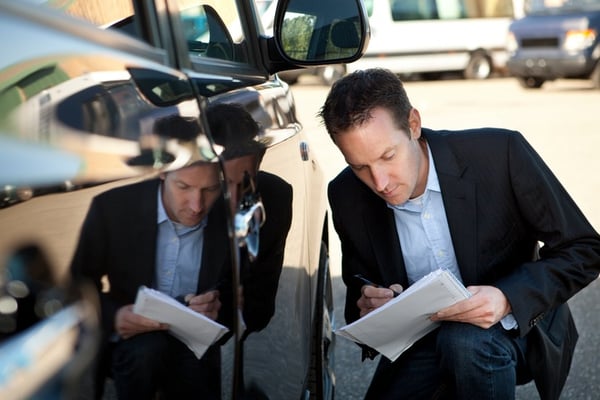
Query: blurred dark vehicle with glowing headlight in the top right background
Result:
<box><xmin>507</xmin><ymin>0</ymin><xmax>600</xmax><ymax>89</ymax></box>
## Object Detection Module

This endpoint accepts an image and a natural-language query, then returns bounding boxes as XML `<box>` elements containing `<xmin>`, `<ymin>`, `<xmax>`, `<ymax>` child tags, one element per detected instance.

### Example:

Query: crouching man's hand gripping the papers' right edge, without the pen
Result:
<box><xmin>431</xmin><ymin>286</ymin><xmax>511</xmax><ymax>329</ymax></box>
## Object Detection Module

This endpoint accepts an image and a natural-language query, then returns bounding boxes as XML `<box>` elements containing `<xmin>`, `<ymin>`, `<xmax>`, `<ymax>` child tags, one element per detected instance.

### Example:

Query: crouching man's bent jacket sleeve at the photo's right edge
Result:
<box><xmin>496</xmin><ymin>134</ymin><xmax>600</xmax><ymax>335</ymax></box>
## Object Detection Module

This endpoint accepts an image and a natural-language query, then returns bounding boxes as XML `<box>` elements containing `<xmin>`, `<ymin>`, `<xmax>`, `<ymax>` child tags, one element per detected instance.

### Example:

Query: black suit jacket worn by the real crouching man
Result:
<box><xmin>328</xmin><ymin>128</ymin><xmax>600</xmax><ymax>399</ymax></box>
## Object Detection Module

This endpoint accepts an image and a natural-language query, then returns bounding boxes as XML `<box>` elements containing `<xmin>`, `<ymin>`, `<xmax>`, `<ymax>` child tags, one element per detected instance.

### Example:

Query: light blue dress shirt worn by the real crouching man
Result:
<box><xmin>388</xmin><ymin>146</ymin><xmax>517</xmax><ymax>329</ymax></box>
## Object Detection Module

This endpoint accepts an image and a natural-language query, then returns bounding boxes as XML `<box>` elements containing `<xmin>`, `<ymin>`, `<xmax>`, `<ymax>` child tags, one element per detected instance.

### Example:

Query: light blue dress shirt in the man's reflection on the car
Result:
<box><xmin>156</xmin><ymin>185</ymin><xmax>206</xmax><ymax>297</ymax></box>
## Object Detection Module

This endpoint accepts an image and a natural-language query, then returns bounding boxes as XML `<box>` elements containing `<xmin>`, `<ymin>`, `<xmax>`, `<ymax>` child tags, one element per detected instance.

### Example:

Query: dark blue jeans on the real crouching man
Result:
<box><xmin>365</xmin><ymin>322</ymin><xmax>530</xmax><ymax>400</ymax></box>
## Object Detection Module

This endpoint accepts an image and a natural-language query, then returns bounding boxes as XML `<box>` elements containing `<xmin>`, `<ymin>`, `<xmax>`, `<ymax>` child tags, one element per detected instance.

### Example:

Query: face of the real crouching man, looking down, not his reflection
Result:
<box><xmin>334</xmin><ymin>108</ymin><xmax>428</xmax><ymax>205</ymax></box>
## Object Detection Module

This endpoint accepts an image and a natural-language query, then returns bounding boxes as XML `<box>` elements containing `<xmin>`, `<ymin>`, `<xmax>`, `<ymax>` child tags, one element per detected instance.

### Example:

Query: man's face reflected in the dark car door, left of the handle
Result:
<box><xmin>161</xmin><ymin>163</ymin><xmax>221</xmax><ymax>226</ymax></box>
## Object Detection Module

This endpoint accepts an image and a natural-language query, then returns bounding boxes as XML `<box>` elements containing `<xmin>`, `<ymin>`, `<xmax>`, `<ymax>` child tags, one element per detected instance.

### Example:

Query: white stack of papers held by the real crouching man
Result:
<box><xmin>335</xmin><ymin>269</ymin><xmax>471</xmax><ymax>361</ymax></box>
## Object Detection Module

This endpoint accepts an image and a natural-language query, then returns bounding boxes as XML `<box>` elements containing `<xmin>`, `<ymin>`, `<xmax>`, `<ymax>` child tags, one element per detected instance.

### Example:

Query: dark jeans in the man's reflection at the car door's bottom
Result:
<box><xmin>111</xmin><ymin>331</ymin><xmax>221</xmax><ymax>400</ymax></box>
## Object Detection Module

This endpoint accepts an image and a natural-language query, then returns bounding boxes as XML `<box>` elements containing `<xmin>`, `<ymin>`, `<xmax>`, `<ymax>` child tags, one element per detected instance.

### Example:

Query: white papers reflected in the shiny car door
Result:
<box><xmin>133</xmin><ymin>286</ymin><xmax>229</xmax><ymax>358</ymax></box>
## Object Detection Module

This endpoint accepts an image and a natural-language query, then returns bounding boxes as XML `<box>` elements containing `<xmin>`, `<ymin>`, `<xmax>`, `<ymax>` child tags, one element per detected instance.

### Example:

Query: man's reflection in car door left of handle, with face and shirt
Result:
<box><xmin>72</xmin><ymin>162</ymin><xmax>233</xmax><ymax>399</ymax></box>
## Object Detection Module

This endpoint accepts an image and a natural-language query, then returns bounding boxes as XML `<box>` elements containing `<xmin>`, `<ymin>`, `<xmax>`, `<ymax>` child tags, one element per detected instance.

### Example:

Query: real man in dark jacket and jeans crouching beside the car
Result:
<box><xmin>320</xmin><ymin>69</ymin><xmax>600</xmax><ymax>400</ymax></box>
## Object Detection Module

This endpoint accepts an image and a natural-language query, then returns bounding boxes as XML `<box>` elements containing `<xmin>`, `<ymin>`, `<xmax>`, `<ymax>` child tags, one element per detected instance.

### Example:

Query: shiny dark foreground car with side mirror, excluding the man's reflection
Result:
<box><xmin>0</xmin><ymin>0</ymin><xmax>369</xmax><ymax>399</ymax></box>
